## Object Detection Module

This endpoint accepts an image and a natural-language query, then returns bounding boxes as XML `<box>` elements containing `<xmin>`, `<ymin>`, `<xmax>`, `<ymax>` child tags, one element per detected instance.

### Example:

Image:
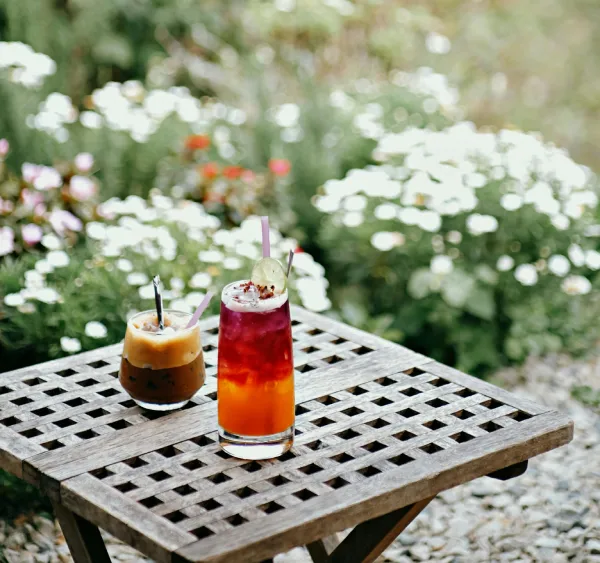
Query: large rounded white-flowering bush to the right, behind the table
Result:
<box><xmin>315</xmin><ymin>123</ymin><xmax>600</xmax><ymax>373</ymax></box>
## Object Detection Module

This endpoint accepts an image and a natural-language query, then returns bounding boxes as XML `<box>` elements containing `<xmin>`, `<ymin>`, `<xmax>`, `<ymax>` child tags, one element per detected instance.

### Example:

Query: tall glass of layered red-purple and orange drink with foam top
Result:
<box><xmin>218</xmin><ymin>281</ymin><xmax>294</xmax><ymax>459</ymax></box>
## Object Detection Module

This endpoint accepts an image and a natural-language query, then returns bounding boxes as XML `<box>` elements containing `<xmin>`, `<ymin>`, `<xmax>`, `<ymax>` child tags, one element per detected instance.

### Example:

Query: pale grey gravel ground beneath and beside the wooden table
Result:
<box><xmin>0</xmin><ymin>357</ymin><xmax>600</xmax><ymax>563</ymax></box>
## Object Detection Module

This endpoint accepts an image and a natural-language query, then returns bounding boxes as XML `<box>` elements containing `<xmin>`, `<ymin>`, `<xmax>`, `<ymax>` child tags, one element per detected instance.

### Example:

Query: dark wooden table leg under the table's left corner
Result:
<box><xmin>52</xmin><ymin>502</ymin><xmax>111</xmax><ymax>563</ymax></box>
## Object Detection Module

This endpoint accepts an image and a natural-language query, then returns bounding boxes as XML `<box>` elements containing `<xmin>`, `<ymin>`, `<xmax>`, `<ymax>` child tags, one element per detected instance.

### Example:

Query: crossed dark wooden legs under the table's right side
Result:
<box><xmin>307</xmin><ymin>497</ymin><xmax>433</xmax><ymax>563</ymax></box>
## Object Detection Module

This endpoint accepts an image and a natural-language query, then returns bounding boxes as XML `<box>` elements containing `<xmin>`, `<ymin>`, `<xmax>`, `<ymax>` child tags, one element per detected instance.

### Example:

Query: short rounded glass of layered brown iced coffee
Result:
<box><xmin>119</xmin><ymin>309</ymin><xmax>206</xmax><ymax>411</ymax></box>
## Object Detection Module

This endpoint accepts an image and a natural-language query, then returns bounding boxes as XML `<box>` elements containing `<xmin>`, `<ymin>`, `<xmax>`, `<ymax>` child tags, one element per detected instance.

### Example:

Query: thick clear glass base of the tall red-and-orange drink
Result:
<box><xmin>219</xmin><ymin>424</ymin><xmax>294</xmax><ymax>460</ymax></box>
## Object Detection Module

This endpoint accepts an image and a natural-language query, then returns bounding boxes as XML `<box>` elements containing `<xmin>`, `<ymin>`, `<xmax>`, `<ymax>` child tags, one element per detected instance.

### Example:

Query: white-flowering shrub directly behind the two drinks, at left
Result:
<box><xmin>0</xmin><ymin>194</ymin><xmax>330</xmax><ymax>370</ymax></box>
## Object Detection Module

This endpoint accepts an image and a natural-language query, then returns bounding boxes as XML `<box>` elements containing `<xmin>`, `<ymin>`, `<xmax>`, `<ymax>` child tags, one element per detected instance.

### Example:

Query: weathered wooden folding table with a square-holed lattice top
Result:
<box><xmin>0</xmin><ymin>307</ymin><xmax>573</xmax><ymax>563</ymax></box>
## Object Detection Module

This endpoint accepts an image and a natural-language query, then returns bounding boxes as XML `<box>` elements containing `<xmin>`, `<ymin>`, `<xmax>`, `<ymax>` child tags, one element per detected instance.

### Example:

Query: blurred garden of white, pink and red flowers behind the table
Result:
<box><xmin>0</xmin><ymin>0</ymin><xmax>600</xmax><ymax>528</ymax></box>
